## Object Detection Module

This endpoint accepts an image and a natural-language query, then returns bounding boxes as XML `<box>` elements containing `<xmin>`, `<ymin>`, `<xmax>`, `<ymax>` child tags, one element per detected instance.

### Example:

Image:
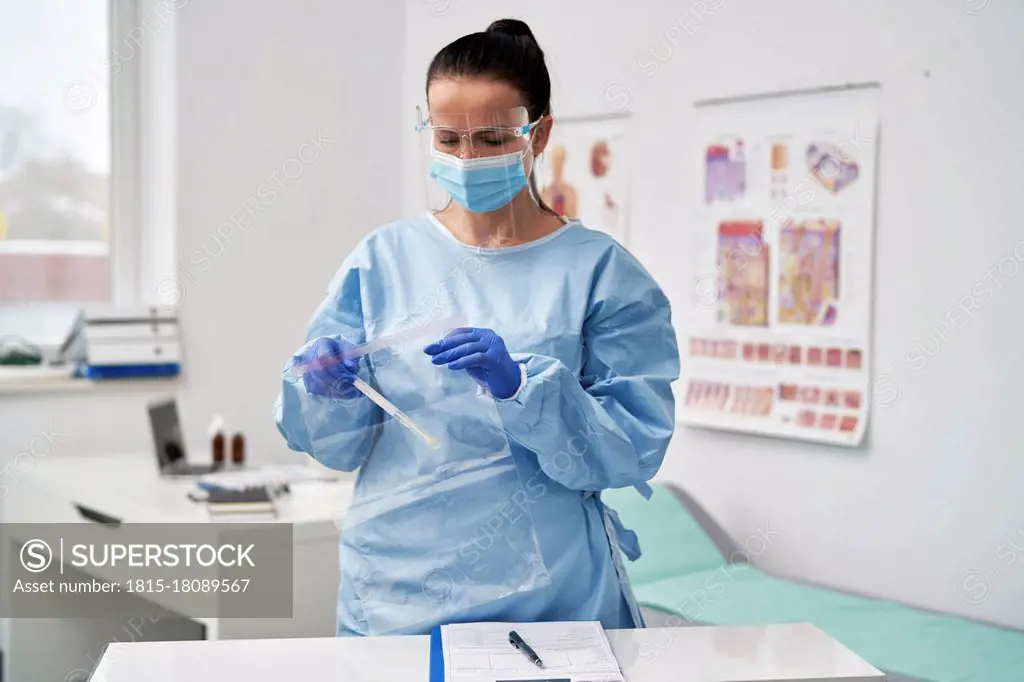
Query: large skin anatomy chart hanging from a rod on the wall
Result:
<box><xmin>674</xmin><ymin>86</ymin><xmax>879</xmax><ymax>446</ymax></box>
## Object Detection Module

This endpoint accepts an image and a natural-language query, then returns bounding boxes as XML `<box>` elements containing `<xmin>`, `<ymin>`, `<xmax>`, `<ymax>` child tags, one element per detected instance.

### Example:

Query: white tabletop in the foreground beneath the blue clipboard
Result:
<box><xmin>90</xmin><ymin>624</ymin><xmax>886</xmax><ymax>682</ymax></box>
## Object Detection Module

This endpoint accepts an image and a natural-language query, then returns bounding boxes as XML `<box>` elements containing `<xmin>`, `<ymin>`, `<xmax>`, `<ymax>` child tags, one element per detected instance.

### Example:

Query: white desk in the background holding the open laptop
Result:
<box><xmin>0</xmin><ymin>454</ymin><xmax>352</xmax><ymax>681</ymax></box>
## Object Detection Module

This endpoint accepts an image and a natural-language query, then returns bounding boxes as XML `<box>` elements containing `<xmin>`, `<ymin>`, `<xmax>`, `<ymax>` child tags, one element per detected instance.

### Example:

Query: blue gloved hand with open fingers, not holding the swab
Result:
<box><xmin>423</xmin><ymin>327</ymin><xmax>522</xmax><ymax>400</ymax></box>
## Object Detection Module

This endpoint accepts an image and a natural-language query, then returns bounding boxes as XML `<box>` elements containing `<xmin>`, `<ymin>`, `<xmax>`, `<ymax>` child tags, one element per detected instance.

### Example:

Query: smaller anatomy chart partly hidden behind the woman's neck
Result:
<box><xmin>537</xmin><ymin>116</ymin><xmax>629</xmax><ymax>245</ymax></box>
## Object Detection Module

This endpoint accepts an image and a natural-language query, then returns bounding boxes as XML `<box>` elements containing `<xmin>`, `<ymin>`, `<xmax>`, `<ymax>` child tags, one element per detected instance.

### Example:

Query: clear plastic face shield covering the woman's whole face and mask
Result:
<box><xmin>416</xmin><ymin>106</ymin><xmax>538</xmax><ymax>213</ymax></box>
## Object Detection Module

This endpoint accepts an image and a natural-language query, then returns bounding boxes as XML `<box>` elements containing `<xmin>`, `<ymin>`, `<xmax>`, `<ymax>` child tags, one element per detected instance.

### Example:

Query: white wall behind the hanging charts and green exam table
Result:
<box><xmin>404</xmin><ymin>0</ymin><xmax>1024</xmax><ymax>628</ymax></box>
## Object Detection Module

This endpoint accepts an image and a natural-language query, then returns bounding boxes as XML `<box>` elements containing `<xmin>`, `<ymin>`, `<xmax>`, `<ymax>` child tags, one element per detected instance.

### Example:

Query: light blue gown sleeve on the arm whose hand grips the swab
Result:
<box><xmin>274</xmin><ymin>245</ymin><xmax>380</xmax><ymax>471</ymax></box>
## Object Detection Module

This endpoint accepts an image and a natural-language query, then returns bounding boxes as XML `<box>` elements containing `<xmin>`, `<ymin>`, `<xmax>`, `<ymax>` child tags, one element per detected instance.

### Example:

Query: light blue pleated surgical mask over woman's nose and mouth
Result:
<box><xmin>430</xmin><ymin>150</ymin><xmax>529</xmax><ymax>213</ymax></box>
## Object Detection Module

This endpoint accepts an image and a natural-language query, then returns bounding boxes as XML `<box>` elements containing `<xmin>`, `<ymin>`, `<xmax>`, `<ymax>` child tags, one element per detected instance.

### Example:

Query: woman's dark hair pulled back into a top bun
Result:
<box><xmin>427</xmin><ymin>18</ymin><xmax>551</xmax><ymax>121</ymax></box>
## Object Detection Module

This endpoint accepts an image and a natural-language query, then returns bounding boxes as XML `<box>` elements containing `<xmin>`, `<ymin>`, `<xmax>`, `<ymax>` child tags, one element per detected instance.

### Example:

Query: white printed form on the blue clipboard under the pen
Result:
<box><xmin>441</xmin><ymin>621</ymin><xmax>624</xmax><ymax>682</ymax></box>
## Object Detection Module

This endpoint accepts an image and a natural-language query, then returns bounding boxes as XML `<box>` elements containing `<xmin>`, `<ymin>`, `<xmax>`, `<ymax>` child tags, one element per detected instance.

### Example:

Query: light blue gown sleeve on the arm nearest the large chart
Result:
<box><xmin>498</xmin><ymin>247</ymin><xmax>679</xmax><ymax>493</ymax></box>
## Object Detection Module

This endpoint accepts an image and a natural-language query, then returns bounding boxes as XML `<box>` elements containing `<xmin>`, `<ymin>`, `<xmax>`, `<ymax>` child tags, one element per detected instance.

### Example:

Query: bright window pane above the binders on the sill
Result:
<box><xmin>0</xmin><ymin>0</ymin><xmax>134</xmax><ymax>305</ymax></box>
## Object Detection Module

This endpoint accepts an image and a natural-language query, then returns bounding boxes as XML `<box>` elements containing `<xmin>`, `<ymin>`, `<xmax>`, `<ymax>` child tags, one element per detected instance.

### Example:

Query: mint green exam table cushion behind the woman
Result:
<box><xmin>602</xmin><ymin>485</ymin><xmax>1024</xmax><ymax>682</ymax></box>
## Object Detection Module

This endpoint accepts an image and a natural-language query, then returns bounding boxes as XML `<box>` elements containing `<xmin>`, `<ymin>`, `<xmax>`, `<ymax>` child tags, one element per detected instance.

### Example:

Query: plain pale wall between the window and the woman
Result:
<box><xmin>0</xmin><ymin>0</ymin><xmax>403</xmax><ymax>483</ymax></box>
